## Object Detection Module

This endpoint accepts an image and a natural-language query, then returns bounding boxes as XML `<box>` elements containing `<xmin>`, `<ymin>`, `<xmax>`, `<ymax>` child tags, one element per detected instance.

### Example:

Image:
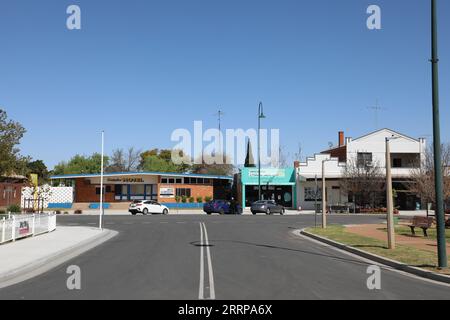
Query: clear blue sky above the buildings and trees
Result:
<box><xmin>0</xmin><ymin>0</ymin><xmax>450</xmax><ymax>167</ymax></box>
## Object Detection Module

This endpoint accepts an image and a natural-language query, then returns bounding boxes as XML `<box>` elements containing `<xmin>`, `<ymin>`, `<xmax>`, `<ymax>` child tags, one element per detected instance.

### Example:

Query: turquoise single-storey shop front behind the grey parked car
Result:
<box><xmin>241</xmin><ymin>168</ymin><xmax>297</xmax><ymax>208</ymax></box>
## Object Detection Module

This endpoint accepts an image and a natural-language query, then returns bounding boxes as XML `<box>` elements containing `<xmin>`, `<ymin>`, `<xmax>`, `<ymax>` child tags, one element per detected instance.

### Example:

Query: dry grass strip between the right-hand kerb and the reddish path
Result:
<box><xmin>306</xmin><ymin>225</ymin><xmax>450</xmax><ymax>275</ymax></box>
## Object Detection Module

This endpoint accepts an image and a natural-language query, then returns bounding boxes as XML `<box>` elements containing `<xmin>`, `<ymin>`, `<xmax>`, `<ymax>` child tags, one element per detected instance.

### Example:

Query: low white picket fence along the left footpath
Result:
<box><xmin>0</xmin><ymin>213</ymin><xmax>56</xmax><ymax>244</ymax></box>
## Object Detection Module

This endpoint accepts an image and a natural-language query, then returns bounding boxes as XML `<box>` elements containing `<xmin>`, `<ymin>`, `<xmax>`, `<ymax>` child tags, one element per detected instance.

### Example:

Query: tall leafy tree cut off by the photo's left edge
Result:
<box><xmin>0</xmin><ymin>109</ymin><xmax>26</xmax><ymax>176</ymax></box>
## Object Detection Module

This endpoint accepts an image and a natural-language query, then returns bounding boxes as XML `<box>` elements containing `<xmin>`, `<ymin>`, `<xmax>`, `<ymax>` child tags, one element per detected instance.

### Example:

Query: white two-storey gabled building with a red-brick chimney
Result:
<box><xmin>296</xmin><ymin>129</ymin><xmax>426</xmax><ymax>210</ymax></box>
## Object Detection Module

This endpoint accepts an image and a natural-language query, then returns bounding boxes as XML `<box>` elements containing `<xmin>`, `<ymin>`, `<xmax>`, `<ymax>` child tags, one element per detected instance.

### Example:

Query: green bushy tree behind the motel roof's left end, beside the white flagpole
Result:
<box><xmin>53</xmin><ymin>153</ymin><xmax>109</xmax><ymax>175</ymax></box>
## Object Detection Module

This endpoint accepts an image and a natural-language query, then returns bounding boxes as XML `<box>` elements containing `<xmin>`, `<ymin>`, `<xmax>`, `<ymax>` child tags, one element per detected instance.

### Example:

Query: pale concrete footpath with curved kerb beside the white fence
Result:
<box><xmin>0</xmin><ymin>226</ymin><xmax>117</xmax><ymax>288</ymax></box>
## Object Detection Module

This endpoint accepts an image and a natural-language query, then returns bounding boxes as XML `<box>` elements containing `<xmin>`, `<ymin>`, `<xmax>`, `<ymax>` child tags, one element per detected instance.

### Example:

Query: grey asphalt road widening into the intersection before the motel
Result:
<box><xmin>0</xmin><ymin>215</ymin><xmax>450</xmax><ymax>300</ymax></box>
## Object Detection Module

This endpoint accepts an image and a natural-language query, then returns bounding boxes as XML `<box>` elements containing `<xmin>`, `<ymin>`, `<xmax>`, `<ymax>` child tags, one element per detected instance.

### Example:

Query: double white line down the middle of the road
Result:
<box><xmin>198</xmin><ymin>222</ymin><xmax>216</xmax><ymax>300</ymax></box>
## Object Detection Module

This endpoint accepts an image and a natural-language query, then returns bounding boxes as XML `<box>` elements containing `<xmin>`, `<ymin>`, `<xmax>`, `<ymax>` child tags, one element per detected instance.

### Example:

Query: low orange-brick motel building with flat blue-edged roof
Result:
<box><xmin>51</xmin><ymin>172</ymin><xmax>233</xmax><ymax>203</ymax></box>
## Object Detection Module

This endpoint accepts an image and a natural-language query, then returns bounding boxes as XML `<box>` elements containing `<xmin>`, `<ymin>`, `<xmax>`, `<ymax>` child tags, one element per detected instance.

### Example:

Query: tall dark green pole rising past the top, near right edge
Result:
<box><xmin>431</xmin><ymin>0</ymin><xmax>448</xmax><ymax>268</ymax></box>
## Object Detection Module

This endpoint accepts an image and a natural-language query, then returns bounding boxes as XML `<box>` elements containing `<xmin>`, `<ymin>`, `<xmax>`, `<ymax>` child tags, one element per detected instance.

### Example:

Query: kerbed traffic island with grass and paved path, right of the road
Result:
<box><xmin>300</xmin><ymin>225</ymin><xmax>450</xmax><ymax>283</ymax></box>
